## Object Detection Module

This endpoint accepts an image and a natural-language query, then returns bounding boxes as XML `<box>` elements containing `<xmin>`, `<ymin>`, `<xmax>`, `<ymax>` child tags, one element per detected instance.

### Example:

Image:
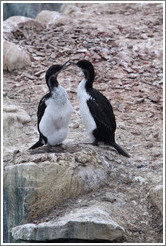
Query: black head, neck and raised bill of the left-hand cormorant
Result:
<box><xmin>45</xmin><ymin>61</ymin><xmax>70</xmax><ymax>91</ymax></box>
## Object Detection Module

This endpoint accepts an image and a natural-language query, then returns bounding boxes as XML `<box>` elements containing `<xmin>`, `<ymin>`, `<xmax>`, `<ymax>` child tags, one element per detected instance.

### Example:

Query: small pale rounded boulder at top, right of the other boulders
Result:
<box><xmin>36</xmin><ymin>10</ymin><xmax>63</xmax><ymax>26</ymax></box>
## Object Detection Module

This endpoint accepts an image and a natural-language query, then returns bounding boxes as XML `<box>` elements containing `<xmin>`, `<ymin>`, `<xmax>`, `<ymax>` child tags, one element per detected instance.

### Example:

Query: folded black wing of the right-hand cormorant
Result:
<box><xmin>88</xmin><ymin>88</ymin><xmax>116</xmax><ymax>132</ymax></box>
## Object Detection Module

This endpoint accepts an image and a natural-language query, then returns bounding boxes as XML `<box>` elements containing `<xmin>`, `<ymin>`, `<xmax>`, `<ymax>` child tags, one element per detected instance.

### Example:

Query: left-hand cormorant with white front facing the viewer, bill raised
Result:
<box><xmin>30</xmin><ymin>61</ymin><xmax>72</xmax><ymax>149</ymax></box>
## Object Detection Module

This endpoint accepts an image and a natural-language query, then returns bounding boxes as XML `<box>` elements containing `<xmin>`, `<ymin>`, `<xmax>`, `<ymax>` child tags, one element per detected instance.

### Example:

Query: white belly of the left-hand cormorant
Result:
<box><xmin>39</xmin><ymin>98</ymin><xmax>72</xmax><ymax>146</ymax></box>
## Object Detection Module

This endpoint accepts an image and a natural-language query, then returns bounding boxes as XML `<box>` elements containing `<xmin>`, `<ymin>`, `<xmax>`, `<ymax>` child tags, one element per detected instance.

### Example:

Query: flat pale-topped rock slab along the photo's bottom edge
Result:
<box><xmin>12</xmin><ymin>206</ymin><xmax>124</xmax><ymax>242</ymax></box>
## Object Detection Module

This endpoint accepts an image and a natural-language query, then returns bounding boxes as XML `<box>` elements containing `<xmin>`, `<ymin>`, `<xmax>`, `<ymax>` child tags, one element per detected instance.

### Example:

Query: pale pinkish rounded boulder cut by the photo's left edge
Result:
<box><xmin>3</xmin><ymin>40</ymin><xmax>31</xmax><ymax>72</ymax></box>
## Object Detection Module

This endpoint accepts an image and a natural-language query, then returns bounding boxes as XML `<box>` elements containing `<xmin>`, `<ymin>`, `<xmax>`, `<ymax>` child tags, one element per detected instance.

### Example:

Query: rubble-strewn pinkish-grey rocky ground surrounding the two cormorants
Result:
<box><xmin>3</xmin><ymin>3</ymin><xmax>163</xmax><ymax>243</ymax></box>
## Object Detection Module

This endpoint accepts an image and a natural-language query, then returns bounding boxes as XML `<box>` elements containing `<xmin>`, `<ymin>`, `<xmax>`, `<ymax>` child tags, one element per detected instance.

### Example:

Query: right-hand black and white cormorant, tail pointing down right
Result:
<box><xmin>70</xmin><ymin>60</ymin><xmax>129</xmax><ymax>157</ymax></box>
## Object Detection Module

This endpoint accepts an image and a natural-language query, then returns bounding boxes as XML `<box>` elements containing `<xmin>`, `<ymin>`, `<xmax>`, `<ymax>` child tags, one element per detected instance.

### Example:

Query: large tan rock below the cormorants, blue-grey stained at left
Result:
<box><xmin>4</xmin><ymin>147</ymin><xmax>108</xmax><ymax>242</ymax></box>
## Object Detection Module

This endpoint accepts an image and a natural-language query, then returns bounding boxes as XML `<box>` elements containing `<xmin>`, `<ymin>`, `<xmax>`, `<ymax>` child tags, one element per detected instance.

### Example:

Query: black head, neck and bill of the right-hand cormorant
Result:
<box><xmin>70</xmin><ymin>60</ymin><xmax>95</xmax><ymax>87</ymax></box>
